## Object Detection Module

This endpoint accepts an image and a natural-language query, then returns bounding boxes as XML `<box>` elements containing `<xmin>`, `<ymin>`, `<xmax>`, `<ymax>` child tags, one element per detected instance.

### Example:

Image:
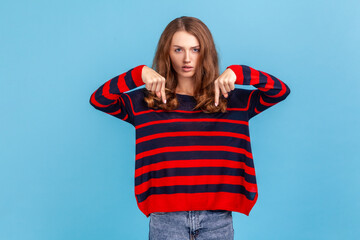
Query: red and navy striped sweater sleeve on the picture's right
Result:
<box><xmin>227</xmin><ymin>65</ymin><xmax>290</xmax><ymax>119</ymax></box>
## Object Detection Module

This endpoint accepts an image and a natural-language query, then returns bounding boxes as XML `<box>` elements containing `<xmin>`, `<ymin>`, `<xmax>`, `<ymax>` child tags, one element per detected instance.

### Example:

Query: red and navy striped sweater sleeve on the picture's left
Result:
<box><xmin>89</xmin><ymin>65</ymin><xmax>145</xmax><ymax>125</ymax></box>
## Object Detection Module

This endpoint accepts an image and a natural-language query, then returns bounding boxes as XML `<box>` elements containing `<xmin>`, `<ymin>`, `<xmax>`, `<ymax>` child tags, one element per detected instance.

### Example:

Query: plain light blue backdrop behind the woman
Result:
<box><xmin>0</xmin><ymin>0</ymin><xmax>360</xmax><ymax>240</ymax></box>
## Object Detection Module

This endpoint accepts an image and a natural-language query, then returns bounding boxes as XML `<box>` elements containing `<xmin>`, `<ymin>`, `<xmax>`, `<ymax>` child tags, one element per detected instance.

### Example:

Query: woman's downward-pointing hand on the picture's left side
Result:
<box><xmin>141</xmin><ymin>65</ymin><xmax>166</xmax><ymax>103</ymax></box>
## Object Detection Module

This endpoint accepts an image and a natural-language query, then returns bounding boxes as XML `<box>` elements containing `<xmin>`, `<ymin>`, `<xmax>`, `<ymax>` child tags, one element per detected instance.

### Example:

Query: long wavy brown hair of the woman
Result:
<box><xmin>144</xmin><ymin>16</ymin><xmax>227</xmax><ymax>113</ymax></box>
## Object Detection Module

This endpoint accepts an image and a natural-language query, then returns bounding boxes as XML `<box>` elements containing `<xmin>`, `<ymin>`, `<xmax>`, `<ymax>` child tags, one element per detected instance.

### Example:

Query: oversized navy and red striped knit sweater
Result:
<box><xmin>90</xmin><ymin>65</ymin><xmax>290</xmax><ymax>217</ymax></box>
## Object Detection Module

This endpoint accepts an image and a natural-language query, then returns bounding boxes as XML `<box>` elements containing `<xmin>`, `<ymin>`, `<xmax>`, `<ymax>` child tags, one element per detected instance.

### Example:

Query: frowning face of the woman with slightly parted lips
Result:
<box><xmin>170</xmin><ymin>31</ymin><xmax>200</xmax><ymax>78</ymax></box>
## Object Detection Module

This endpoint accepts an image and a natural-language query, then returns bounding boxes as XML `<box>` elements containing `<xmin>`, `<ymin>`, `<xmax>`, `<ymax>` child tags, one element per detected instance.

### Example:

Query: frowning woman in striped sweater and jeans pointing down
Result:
<box><xmin>90</xmin><ymin>16</ymin><xmax>290</xmax><ymax>240</ymax></box>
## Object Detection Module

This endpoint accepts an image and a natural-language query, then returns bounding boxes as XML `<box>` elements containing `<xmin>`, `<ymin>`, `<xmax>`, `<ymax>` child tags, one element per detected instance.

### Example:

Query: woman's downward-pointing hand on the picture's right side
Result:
<box><xmin>214</xmin><ymin>68</ymin><xmax>236</xmax><ymax>106</ymax></box>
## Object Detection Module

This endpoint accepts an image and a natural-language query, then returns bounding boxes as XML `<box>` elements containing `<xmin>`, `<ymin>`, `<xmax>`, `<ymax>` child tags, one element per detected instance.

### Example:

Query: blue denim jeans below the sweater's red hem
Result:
<box><xmin>149</xmin><ymin>210</ymin><xmax>234</xmax><ymax>240</ymax></box>
